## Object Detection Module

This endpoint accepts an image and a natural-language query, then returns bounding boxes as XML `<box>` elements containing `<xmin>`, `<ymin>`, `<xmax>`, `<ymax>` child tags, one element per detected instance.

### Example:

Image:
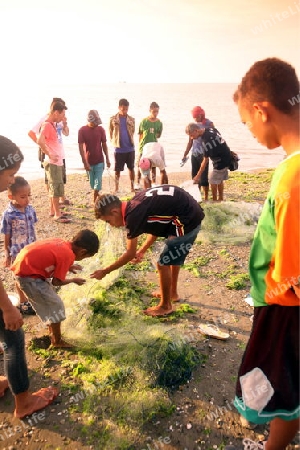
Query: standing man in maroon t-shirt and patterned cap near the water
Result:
<box><xmin>78</xmin><ymin>109</ymin><xmax>110</xmax><ymax>203</ymax></box>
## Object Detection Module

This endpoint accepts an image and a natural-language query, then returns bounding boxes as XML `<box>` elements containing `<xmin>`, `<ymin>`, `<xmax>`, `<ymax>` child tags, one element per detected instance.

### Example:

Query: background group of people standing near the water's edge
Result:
<box><xmin>28</xmin><ymin>93</ymin><xmax>231</xmax><ymax>214</ymax></box>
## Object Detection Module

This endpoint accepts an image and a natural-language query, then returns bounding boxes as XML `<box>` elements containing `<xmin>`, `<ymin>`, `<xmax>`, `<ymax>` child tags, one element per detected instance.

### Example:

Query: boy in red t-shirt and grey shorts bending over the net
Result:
<box><xmin>11</xmin><ymin>230</ymin><xmax>99</xmax><ymax>348</ymax></box>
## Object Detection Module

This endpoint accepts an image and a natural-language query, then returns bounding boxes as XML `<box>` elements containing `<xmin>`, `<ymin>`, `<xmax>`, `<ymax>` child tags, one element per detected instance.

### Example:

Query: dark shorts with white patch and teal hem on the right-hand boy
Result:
<box><xmin>234</xmin><ymin>305</ymin><xmax>300</xmax><ymax>424</ymax></box>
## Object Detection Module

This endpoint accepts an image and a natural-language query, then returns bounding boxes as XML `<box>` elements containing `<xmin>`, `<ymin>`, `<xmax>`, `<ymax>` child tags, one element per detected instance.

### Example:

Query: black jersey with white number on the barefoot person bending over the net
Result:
<box><xmin>125</xmin><ymin>184</ymin><xmax>204</xmax><ymax>239</ymax></box>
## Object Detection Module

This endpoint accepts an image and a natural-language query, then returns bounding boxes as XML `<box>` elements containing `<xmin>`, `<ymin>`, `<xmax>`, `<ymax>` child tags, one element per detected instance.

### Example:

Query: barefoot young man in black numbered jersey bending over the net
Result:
<box><xmin>91</xmin><ymin>185</ymin><xmax>204</xmax><ymax>316</ymax></box>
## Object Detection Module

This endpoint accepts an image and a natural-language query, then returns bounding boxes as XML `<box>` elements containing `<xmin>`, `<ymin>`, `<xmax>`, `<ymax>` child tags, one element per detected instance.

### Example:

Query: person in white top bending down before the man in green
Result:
<box><xmin>139</xmin><ymin>142</ymin><xmax>168</xmax><ymax>189</ymax></box>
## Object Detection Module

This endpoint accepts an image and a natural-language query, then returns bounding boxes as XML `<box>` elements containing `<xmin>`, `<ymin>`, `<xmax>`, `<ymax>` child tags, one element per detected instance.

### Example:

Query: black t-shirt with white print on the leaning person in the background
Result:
<box><xmin>201</xmin><ymin>128</ymin><xmax>230</xmax><ymax>170</ymax></box>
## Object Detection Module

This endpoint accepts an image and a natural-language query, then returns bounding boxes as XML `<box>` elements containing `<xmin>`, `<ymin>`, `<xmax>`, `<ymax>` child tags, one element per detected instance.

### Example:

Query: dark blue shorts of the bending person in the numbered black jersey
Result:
<box><xmin>158</xmin><ymin>225</ymin><xmax>200</xmax><ymax>266</ymax></box>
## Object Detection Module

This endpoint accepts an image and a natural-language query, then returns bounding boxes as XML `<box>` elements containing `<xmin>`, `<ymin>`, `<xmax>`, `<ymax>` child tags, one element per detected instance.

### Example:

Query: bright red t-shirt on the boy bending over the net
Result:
<box><xmin>11</xmin><ymin>238</ymin><xmax>75</xmax><ymax>281</ymax></box>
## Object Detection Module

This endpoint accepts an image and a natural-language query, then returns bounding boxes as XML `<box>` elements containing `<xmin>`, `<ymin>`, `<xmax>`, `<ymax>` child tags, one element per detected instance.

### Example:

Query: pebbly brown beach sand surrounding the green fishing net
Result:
<box><xmin>0</xmin><ymin>171</ymin><xmax>299</xmax><ymax>450</ymax></box>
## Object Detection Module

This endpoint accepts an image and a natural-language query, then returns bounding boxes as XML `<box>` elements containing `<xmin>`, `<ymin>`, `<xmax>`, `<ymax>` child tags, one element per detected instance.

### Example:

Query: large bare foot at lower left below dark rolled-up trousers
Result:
<box><xmin>14</xmin><ymin>386</ymin><xmax>58</xmax><ymax>419</ymax></box>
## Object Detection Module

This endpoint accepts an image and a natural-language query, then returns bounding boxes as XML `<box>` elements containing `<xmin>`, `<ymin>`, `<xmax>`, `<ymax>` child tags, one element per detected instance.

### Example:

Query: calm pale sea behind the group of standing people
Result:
<box><xmin>0</xmin><ymin>82</ymin><xmax>284</xmax><ymax>179</ymax></box>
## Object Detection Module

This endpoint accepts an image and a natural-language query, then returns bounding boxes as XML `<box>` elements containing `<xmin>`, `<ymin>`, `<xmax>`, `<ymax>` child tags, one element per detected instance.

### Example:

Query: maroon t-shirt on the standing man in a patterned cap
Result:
<box><xmin>78</xmin><ymin>125</ymin><xmax>106</xmax><ymax>166</ymax></box>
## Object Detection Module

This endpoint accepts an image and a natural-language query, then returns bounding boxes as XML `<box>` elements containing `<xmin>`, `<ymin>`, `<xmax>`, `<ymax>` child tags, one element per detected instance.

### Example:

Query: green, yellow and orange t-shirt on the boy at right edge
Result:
<box><xmin>249</xmin><ymin>151</ymin><xmax>300</xmax><ymax>306</ymax></box>
